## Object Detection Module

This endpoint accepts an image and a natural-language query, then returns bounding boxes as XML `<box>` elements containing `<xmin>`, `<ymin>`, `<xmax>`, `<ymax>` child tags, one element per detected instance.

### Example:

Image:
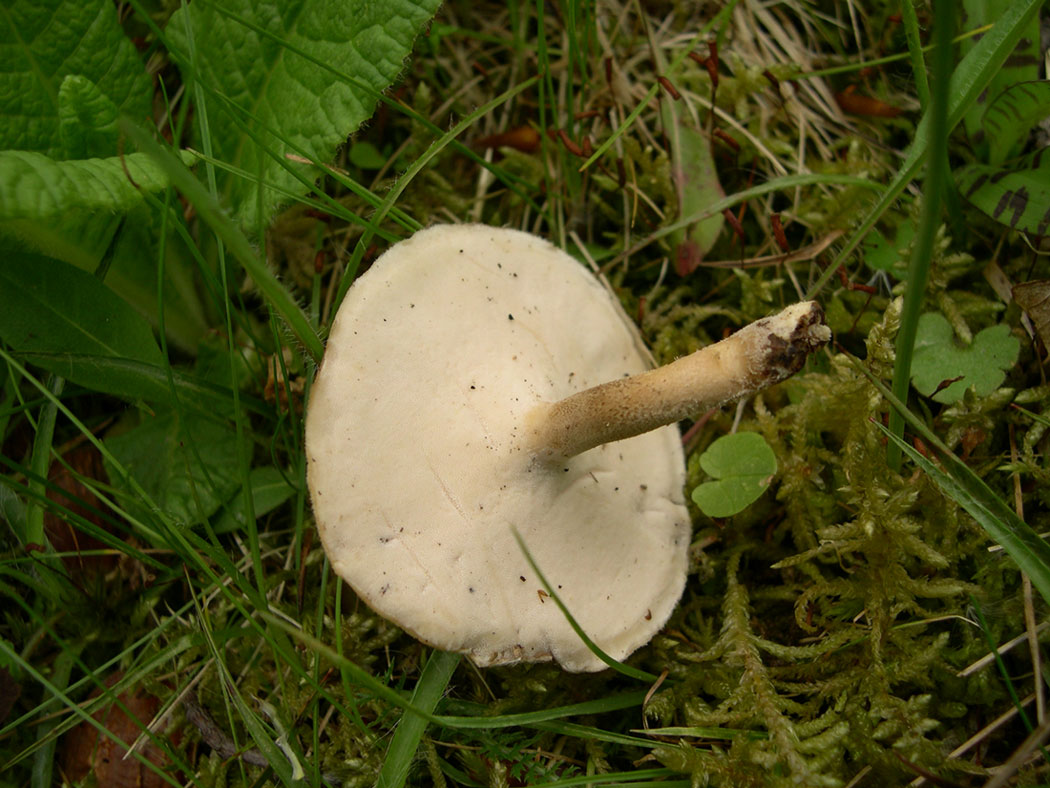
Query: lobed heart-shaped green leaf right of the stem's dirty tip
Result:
<box><xmin>911</xmin><ymin>312</ymin><xmax>1021</xmax><ymax>405</ymax></box>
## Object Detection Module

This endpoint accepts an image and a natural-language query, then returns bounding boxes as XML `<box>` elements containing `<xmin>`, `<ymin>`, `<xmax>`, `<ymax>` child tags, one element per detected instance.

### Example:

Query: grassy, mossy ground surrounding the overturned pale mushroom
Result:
<box><xmin>0</xmin><ymin>0</ymin><xmax>1050</xmax><ymax>788</ymax></box>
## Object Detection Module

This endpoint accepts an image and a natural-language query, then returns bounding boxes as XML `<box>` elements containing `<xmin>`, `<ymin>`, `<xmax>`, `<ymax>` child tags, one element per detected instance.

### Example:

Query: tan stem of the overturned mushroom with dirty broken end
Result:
<box><xmin>526</xmin><ymin>302</ymin><xmax>832</xmax><ymax>462</ymax></box>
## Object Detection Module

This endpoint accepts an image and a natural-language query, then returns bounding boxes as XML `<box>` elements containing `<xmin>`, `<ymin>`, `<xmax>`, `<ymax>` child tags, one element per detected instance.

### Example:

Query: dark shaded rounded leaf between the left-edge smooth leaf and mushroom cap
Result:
<box><xmin>105</xmin><ymin>410</ymin><xmax>240</xmax><ymax>523</ymax></box>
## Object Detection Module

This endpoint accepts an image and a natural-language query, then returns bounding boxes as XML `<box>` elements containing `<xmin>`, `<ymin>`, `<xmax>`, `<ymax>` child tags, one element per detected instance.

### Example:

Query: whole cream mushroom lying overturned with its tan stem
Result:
<box><xmin>307</xmin><ymin>225</ymin><xmax>831</xmax><ymax>671</ymax></box>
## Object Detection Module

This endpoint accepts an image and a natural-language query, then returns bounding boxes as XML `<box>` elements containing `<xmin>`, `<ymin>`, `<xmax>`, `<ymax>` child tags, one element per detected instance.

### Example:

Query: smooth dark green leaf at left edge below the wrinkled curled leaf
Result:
<box><xmin>0</xmin><ymin>254</ymin><xmax>163</xmax><ymax>391</ymax></box>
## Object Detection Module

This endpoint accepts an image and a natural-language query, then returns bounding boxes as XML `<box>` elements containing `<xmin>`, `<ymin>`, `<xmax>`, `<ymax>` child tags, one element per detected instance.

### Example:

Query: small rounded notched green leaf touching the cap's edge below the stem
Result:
<box><xmin>693</xmin><ymin>432</ymin><xmax>777</xmax><ymax>517</ymax></box>
